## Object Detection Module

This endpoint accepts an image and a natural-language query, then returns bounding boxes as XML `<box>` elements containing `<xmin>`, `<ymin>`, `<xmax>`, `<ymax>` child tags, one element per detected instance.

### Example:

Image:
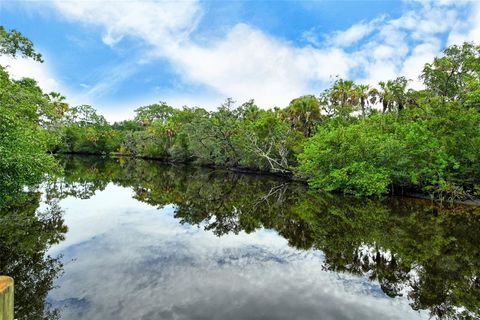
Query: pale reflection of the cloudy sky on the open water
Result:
<box><xmin>49</xmin><ymin>185</ymin><xmax>428</xmax><ymax>320</ymax></box>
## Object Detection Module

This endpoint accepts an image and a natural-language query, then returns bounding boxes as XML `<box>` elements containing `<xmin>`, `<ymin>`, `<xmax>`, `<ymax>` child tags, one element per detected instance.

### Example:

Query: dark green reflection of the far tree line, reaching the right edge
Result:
<box><xmin>56</xmin><ymin>158</ymin><xmax>480</xmax><ymax>319</ymax></box>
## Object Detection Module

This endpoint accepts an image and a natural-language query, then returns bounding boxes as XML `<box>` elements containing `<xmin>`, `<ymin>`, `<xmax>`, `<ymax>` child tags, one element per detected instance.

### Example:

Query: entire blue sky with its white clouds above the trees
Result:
<box><xmin>0</xmin><ymin>0</ymin><xmax>480</xmax><ymax>121</ymax></box>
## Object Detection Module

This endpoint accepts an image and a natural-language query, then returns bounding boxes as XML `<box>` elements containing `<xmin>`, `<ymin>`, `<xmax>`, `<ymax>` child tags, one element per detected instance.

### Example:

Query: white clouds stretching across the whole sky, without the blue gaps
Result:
<box><xmin>3</xmin><ymin>1</ymin><xmax>480</xmax><ymax>119</ymax></box>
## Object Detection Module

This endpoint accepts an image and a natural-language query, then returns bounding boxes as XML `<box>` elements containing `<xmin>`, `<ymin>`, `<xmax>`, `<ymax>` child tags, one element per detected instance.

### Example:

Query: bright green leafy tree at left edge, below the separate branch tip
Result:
<box><xmin>0</xmin><ymin>68</ymin><xmax>55</xmax><ymax>202</ymax></box>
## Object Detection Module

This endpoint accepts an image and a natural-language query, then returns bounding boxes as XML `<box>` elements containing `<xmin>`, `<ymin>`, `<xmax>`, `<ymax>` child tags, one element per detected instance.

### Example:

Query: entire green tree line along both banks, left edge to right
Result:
<box><xmin>0</xmin><ymin>28</ymin><xmax>480</xmax><ymax>199</ymax></box>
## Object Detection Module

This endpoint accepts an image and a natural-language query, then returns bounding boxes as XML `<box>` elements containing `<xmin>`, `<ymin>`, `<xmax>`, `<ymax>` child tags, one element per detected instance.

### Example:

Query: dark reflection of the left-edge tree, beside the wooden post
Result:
<box><xmin>0</xmin><ymin>193</ymin><xmax>67</xmax><ymax>320</ymax></box>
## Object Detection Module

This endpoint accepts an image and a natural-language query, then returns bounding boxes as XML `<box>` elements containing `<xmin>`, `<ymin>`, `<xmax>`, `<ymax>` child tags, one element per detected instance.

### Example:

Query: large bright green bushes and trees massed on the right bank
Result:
<box><xmin>298</xmin><ymin>43</ymin><xmax>480</xmax><ymax>198</ymax></box>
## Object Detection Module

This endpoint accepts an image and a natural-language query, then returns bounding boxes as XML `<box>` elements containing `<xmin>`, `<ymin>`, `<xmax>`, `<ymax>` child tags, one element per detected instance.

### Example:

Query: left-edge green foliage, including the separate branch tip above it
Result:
<box><xmin>0</xmin><ymin>28</ymin><xmax>61</xmax><ymax>205</ymax></box>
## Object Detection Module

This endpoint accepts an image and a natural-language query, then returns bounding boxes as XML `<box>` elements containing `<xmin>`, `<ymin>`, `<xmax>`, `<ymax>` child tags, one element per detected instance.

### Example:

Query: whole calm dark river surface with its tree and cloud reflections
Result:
<box><xmin>0</xmin><ymin>157</ymin><xmax>480</xmax><ymax>320</ymax></box>
